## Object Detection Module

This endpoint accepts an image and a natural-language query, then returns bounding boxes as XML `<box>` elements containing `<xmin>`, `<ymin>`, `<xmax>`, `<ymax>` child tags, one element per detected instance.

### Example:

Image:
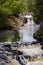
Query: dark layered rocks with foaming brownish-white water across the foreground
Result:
<box><xmin>0</xmin><ymin>42</ymin><xmax>43</xmax><ymax>65</ymax></box>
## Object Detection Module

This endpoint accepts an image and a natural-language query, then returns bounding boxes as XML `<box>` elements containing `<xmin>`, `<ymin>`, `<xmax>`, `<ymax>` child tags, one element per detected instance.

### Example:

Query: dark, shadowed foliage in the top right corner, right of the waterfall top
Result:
<box><xmin>34</xmin><ymin>0</ymin><xmax>43</xmax><ymax>23</ymax></box>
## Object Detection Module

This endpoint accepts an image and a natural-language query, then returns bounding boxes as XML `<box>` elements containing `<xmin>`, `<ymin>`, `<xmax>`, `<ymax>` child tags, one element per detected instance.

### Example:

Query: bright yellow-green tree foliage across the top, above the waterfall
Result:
<box><xmin>0</xmin><ymin>0</ymin><xmax>35</xmax><ymax>16</ymax></box>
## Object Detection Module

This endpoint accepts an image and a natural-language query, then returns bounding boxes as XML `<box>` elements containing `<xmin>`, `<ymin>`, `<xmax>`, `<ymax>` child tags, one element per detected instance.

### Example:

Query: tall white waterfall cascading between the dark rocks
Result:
<box><xmin>19</xmin><ymin>15</ymin><xmax>39</xmax><ymax>42</ymax></box>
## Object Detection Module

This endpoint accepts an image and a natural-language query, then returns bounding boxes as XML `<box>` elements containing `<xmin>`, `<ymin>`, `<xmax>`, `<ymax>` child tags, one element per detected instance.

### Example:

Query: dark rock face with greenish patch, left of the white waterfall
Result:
<box><xmin>0</xmin><ymin>28</ymin><xmax>19</xmax><ymax>42</ymax></box>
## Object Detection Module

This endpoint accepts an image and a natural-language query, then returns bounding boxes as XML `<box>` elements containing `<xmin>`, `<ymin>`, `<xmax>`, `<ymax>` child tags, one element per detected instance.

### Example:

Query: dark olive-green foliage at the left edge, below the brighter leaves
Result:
<box><xmin>0</xmin><ymin>7</ymin><xmax>10</xmax><ymax>29</ymax></box>
